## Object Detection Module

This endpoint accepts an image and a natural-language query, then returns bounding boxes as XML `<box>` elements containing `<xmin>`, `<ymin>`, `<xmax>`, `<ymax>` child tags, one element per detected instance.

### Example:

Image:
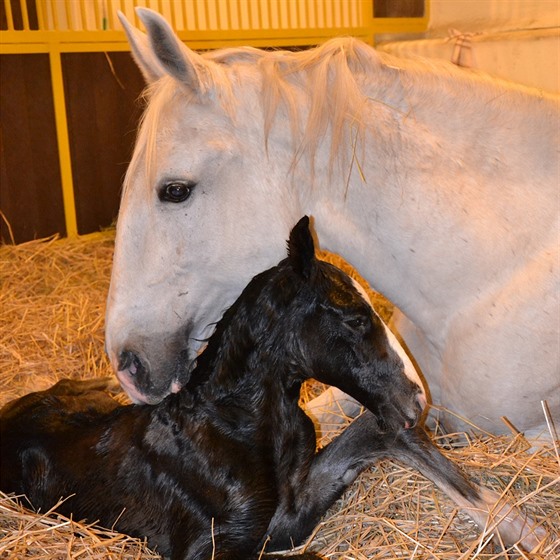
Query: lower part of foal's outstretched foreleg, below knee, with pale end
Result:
<box><xmin>389</xmin><ymin>427</ymin><xmax>546</xmax><ymax>551</ymax></box>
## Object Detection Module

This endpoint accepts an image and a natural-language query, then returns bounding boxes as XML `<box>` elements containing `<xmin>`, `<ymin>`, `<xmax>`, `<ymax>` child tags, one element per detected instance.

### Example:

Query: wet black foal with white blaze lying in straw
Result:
<box><xmin>0</xmin><ymin>219</ymin><xmax>544</xmax><ymax>560</ymax></box>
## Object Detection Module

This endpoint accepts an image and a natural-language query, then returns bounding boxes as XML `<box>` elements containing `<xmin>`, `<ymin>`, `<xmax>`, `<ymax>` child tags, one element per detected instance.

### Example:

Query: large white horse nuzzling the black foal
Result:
<box><xmin>106</xmin><ymin>9</ymin><xmax>560</xmax><ymax>436</ymax></box>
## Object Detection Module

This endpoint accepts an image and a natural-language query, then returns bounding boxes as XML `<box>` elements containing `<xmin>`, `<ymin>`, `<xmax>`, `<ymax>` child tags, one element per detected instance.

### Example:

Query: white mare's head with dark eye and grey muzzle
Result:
<box><xmin>106</xmin><ymin>8</ymin><xmax>380</xmax><ymax>403</ymax></box>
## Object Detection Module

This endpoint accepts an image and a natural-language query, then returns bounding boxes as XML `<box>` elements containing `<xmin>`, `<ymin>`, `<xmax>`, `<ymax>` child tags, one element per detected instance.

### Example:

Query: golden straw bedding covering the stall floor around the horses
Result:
<box><xmin>0</xmin><ymin>231</ymin><xmax>560</xmax><ymax>560</ymax></box>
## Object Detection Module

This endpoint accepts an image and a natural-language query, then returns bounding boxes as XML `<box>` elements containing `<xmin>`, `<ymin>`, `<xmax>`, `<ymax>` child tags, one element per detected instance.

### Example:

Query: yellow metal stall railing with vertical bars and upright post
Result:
<box><xmin>0</xmin><ymin>0</ymin><xmax>429</xmax><ymax>237</ymax></box>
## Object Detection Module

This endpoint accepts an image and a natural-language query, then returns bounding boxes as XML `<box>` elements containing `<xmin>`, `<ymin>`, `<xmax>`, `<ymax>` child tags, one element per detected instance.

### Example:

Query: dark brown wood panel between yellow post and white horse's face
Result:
<box><xmin>62</xmin><ymin>52</ymin><xmax>144</xmax><ymax>234</ymax></box>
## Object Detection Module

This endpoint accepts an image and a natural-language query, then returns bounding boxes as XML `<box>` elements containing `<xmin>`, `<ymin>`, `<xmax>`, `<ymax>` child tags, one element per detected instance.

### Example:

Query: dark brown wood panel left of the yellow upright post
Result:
<box><xmin>0</xmin><ymin>54</ymin><xmax>66</xmax><ymax>243</ymax></box>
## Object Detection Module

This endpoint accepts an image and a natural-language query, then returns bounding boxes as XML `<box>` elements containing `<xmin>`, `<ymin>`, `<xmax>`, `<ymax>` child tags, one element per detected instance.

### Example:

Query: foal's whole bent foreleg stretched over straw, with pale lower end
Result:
<box><xmin>267</xmin><ymin>411</ymin><xmax>546</xmax><ymax>550</ymax></box>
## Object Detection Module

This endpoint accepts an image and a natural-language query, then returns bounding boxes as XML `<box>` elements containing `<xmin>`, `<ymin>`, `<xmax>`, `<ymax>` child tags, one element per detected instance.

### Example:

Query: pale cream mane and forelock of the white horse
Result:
<box><xmin>125</xmin><ymin>37</ymin><xmax>552</xmax><ymax>190</ymax></box>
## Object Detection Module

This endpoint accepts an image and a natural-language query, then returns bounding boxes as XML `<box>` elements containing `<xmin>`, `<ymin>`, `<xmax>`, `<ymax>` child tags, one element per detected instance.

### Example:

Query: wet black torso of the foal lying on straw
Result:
<box><xmin>2</xmin><ymin>377</ymin><xmax>316</xmax><ymax>560</ymax></box>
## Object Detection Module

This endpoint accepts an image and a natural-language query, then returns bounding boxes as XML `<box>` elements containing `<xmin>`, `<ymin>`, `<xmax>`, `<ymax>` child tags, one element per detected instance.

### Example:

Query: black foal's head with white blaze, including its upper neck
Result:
<box><xmin>210</xmin><ymin>217</ymin><xmax>426</xmax><ymax>431</ymax></box>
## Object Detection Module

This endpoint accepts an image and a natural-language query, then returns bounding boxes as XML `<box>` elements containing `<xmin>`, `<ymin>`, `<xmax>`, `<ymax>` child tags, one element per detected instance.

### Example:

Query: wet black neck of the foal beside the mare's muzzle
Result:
<box><xmin>175</xmin><ymin>270</ymin><xmax>310</xmax><ymax>445</ymax></box>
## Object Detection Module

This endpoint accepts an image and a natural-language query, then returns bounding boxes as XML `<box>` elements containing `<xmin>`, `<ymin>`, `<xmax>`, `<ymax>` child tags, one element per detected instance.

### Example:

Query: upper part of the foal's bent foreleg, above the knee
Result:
<box><xmin>267</xmin><ymin>411</ymin><xmax>394</xmax><ymax>550</ymax></box>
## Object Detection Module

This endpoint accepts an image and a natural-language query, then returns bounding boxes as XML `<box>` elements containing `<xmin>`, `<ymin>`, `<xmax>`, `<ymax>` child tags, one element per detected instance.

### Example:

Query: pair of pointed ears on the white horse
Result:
<box><xmin>119</xmin><ymin>8</ymin><xmax>207</xmax><ymax>94</ymax></box>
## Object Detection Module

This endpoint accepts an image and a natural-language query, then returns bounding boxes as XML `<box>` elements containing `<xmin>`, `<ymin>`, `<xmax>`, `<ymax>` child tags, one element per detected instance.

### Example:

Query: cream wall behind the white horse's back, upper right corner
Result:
<box><xmin>379</xmin><ymin>0</ymin><xmax>560</xmax><ymax>93</ymax></box>
